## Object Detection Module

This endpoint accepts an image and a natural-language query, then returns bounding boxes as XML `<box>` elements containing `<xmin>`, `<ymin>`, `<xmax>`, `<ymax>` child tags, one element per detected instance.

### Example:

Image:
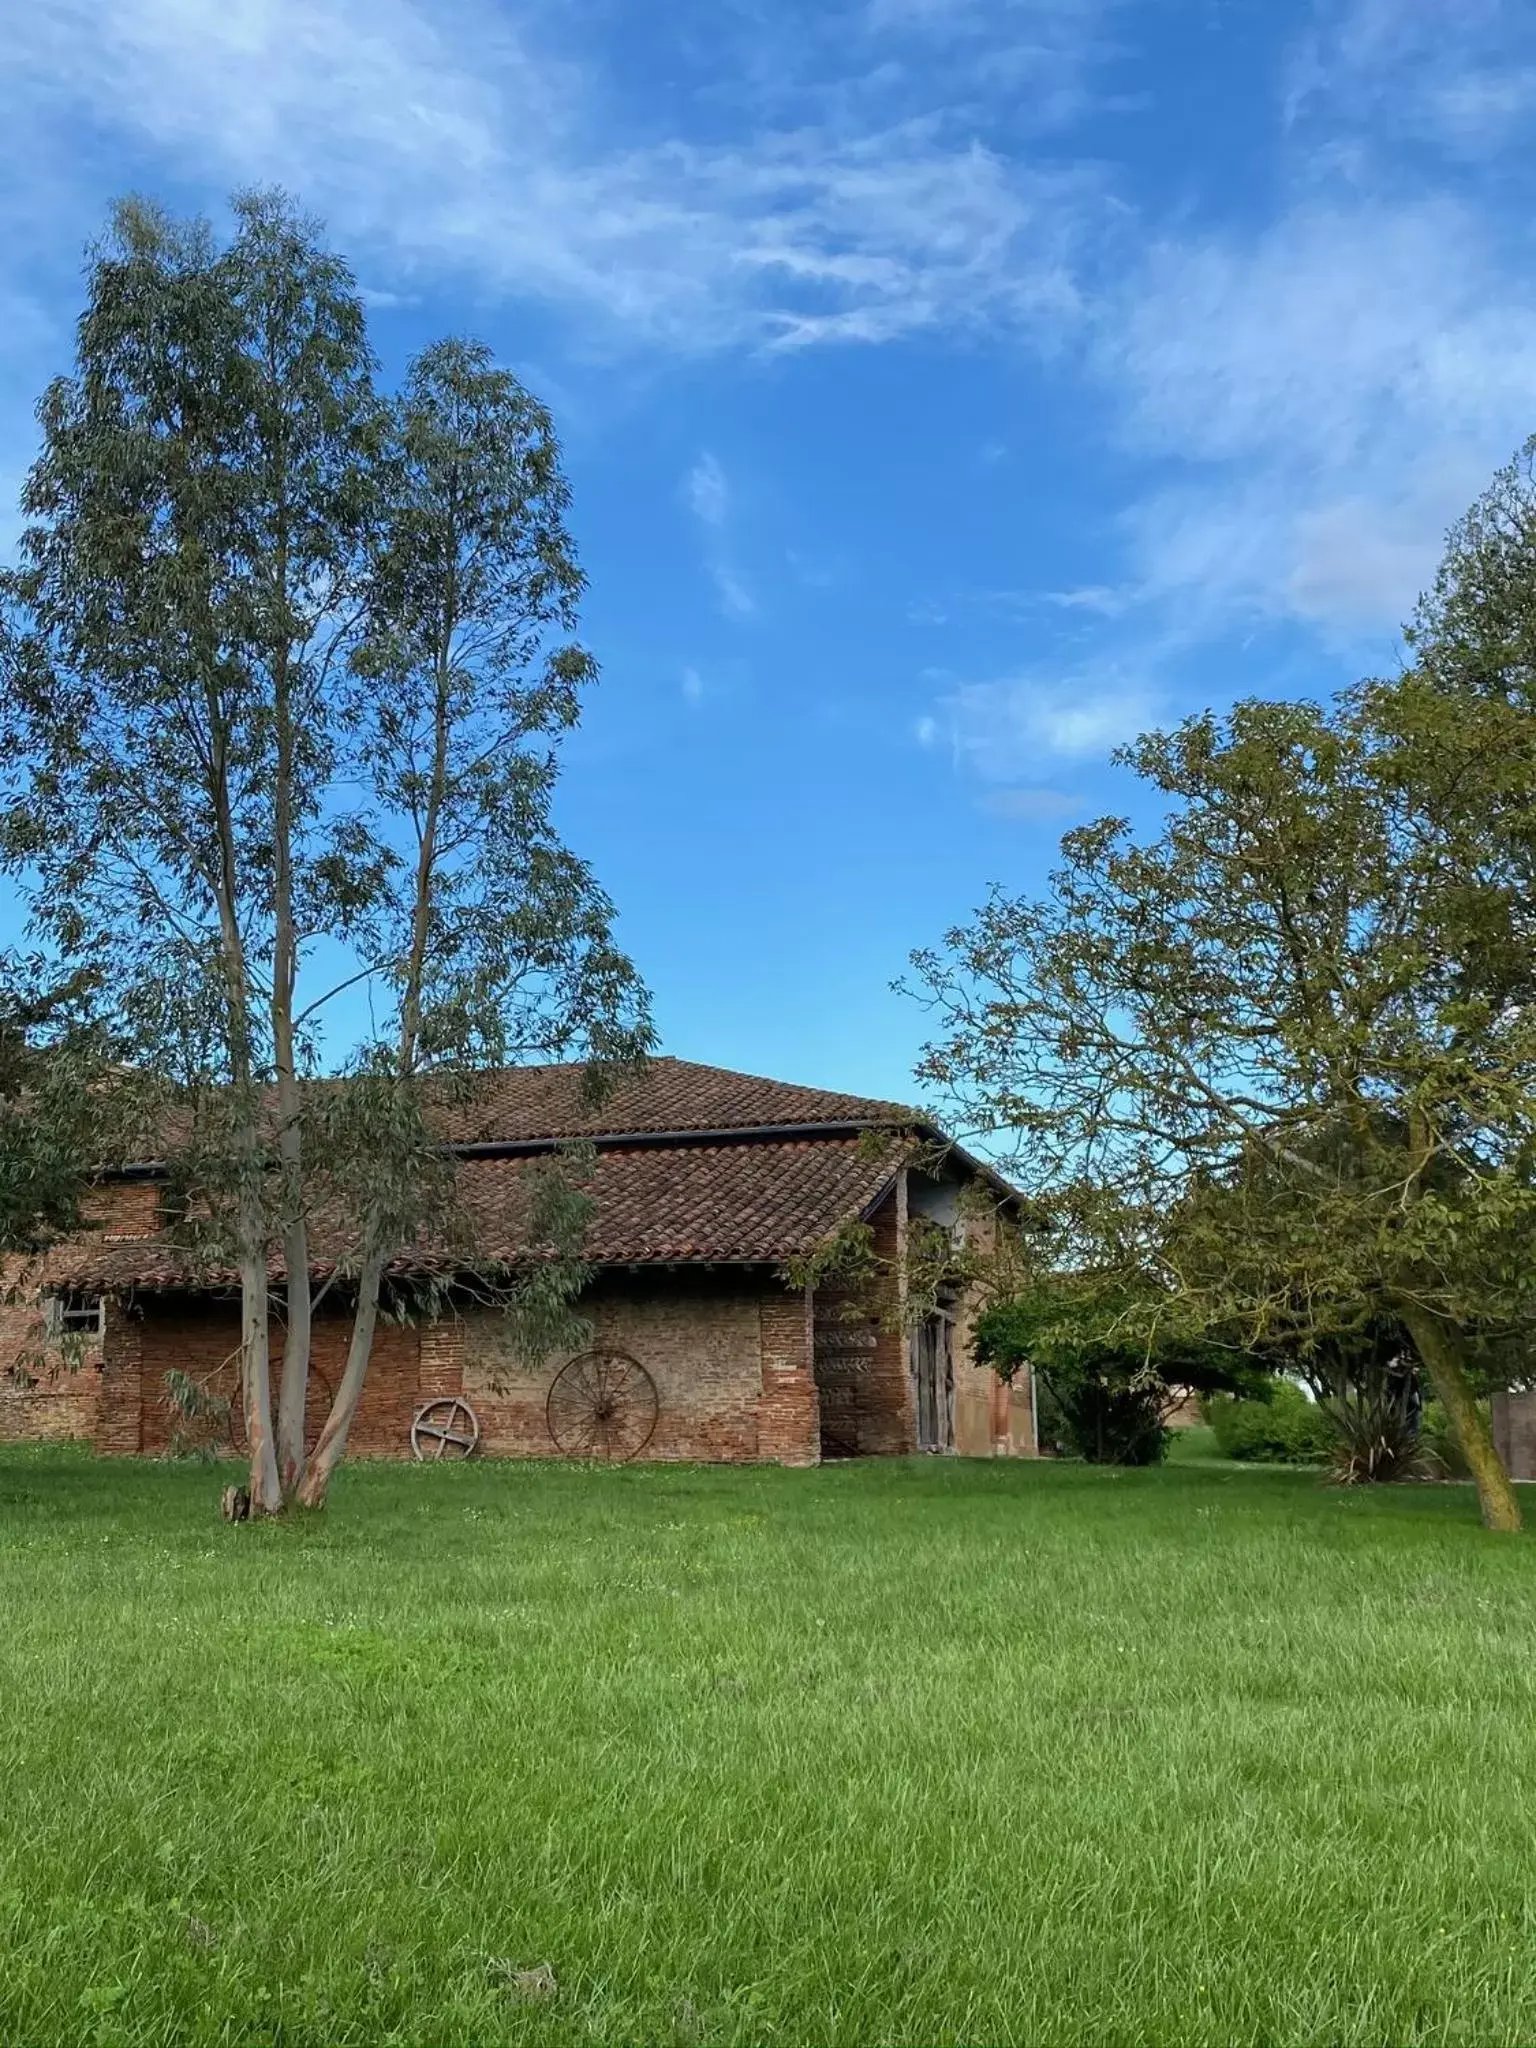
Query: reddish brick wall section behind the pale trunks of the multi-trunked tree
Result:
<box><xmin>123</xmin><ymin>1298</ymin><xmax>422</xmax><ymax>1458</ymax></box>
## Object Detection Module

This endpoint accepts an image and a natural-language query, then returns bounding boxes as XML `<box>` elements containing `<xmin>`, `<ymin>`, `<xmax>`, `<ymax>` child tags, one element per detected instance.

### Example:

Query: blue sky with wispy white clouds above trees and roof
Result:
<box><xmin>0</xmin><ymin>0</ymin><xmax>1536</xmax><ymax>1096</ymax></box>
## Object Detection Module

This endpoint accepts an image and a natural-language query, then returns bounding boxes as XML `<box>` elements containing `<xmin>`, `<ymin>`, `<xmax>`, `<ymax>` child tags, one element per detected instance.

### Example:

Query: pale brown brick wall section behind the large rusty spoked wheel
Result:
<box><xmin>463</xmin><ymin>1272</ymin><xmax>817</xmax><ymax>1464</ymax></box>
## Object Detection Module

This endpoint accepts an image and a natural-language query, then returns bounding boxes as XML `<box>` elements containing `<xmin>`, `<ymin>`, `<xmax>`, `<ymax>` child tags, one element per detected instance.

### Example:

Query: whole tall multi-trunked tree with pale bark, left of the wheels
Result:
<box><xmin>0</xmin><ymin>195</ymin><xmax>645</xmax><ymax>1511</ymax></box>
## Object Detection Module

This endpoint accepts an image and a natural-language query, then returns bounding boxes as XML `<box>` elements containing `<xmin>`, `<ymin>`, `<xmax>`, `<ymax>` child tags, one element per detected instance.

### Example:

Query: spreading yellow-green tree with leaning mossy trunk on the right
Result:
<box><xmin>918</xmin><ymin>692</ymin><xmax>1536</xmax><ymax>1528</ymax></box>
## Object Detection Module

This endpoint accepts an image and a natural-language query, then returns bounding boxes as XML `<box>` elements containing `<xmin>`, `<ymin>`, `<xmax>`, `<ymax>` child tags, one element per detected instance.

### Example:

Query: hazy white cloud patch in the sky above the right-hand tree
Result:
<box><xmin>1098</xmin><ymin>199</ymin><xmax>1536</xmax><ymax>637</ymax></box>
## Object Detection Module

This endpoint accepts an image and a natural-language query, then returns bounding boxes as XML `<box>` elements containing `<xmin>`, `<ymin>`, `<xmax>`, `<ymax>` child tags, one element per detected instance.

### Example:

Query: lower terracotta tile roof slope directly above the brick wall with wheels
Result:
<box><xmin>66</xmin><ymin>1130</ymin><xmax>901</xmax><ymax>1292</ymax></box>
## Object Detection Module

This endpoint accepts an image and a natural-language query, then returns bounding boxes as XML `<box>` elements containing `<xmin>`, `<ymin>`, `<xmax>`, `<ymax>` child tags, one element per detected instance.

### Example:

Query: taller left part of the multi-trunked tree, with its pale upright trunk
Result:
<box><xmin>6</xmin><ymin>195</ymin><xmax>379</xmax><ymax>1509</ymax></box>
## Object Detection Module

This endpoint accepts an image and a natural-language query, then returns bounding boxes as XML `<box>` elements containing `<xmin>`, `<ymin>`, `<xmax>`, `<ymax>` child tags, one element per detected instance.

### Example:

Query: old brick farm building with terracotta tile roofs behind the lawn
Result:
<box><xmin>0</xmin><ymin>1059</ymin><xmax>1034</xmax><ymax>1464</ymax></box>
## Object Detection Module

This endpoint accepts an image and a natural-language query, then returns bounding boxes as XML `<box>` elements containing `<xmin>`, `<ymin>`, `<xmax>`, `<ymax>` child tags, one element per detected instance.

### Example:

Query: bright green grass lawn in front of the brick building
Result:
<box><xmin>0</xmin><ymin>1444</ymin><xmax>1536</xmax><ymax>2048</ymax></box>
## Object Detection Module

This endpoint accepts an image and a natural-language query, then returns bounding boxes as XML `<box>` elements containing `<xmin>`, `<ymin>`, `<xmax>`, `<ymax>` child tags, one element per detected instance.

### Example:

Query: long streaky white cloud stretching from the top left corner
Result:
<box><xmin>0</xmin><ymin>0</ymin><xmax>1094</xmax><ymax>348</ymax></box>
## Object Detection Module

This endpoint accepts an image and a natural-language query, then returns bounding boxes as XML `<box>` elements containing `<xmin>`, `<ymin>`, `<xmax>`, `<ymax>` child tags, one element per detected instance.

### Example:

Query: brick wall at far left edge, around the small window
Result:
<box><xmin>0</xmin><ymin>1182</ymin><xmax>160</xmax><ymax>1444</ymax></box>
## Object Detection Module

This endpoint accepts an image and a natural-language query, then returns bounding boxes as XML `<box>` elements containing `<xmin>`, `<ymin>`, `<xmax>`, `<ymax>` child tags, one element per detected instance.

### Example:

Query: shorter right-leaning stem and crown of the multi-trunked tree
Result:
<box><xmin>299</xmin><ymin>340</ymin><xmax>649</xmax><ymax>1505</ymax></box>
